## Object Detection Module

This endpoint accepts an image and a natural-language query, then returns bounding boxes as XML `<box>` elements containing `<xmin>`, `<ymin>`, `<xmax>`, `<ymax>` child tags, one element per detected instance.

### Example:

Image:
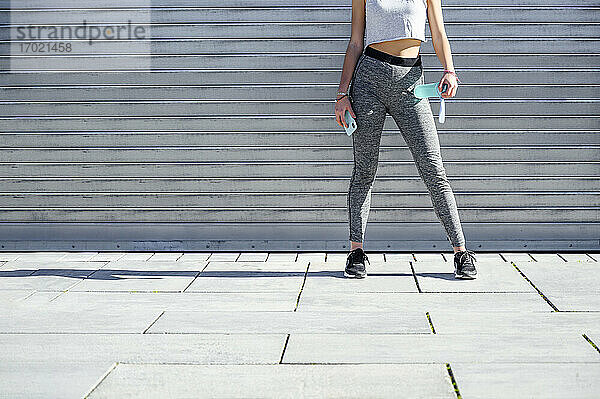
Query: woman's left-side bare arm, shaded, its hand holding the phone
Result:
<box><xmin>335</xmin><ymin>0</ymin><xmax>365</xmax><ymax>126</ymax></box>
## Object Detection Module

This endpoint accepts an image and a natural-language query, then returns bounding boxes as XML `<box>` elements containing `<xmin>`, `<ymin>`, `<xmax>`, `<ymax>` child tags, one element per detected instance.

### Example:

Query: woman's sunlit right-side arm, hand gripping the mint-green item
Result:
<box><xmin>427</xmin><ymin>0</ymin><xmax>458</xmax><ymax>98</ymax></box>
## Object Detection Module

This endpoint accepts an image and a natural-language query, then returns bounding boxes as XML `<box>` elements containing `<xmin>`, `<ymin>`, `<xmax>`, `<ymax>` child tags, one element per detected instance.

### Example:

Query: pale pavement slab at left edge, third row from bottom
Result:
<box><xmin>0</xmin><ymin>305</ymin><xmax>161</xmax><ymax>334</ymax></box>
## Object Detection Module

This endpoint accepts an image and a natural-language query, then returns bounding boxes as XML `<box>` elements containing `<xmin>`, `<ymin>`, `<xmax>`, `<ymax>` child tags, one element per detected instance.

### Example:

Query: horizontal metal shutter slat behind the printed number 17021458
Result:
<box><xmin>0</xmin><ymin>38</ymin><xmax>600</xmax><ymax>54</ymax></box>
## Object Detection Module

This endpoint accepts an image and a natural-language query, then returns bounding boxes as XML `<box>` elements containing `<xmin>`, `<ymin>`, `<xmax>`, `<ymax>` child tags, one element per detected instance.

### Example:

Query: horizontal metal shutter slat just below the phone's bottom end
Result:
<box><xmin>0</xmin><ymin>133</ymin><xmax>600</xmax><ymax>148</ymax></box>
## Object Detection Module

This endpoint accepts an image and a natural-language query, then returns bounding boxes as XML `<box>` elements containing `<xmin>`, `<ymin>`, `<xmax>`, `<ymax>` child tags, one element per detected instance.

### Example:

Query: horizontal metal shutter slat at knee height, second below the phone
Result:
<box><xmin>0</xmin><ymin>145</ymin><xmax>600</xmax><ymax>163</ymax></box>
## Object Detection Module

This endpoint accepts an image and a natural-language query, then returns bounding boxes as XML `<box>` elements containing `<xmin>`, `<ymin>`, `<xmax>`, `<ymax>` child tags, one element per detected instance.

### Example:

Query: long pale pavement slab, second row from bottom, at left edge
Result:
<box><xmin>0</xmin><ymin>334</ymin><xmax>287</xmax><ymax>368</ymax></box>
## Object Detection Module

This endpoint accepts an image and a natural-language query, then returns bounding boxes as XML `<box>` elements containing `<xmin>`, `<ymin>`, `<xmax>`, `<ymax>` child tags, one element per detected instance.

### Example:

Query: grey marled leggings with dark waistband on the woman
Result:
<box><xmin>348</xmin><ymin>46</ymin><xmax>465</xmax><ymax>246</ymax></box>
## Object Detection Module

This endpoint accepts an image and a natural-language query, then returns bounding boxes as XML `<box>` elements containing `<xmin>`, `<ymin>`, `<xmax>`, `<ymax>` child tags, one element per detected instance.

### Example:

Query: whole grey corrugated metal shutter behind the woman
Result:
<box><xmin>0</xmin><ymin>0</ymin><xmax>600</xmax><ymax>250</ymax></box>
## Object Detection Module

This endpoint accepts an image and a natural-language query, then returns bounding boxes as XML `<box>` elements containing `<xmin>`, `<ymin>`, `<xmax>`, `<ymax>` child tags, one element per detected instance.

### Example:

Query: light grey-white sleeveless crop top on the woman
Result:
<box><xmin>365</xmin><ymin>0</ymin><xmax>427</xmax><ymax>46</ymax></box>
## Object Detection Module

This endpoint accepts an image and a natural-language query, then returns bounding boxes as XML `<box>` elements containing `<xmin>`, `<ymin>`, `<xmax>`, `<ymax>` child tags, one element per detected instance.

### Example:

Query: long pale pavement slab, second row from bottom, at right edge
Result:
<box><xmin>283</xmin><ymin>333</ymin><xmax>600</xmax><ymax>363</ymax></box>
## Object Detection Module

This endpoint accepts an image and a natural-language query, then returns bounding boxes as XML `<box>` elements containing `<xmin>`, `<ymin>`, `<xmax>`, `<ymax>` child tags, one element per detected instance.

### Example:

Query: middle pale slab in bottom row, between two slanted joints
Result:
<box><xmin>89</xmin><ymin>363</ymin><xmax>456</xmax><ymax>399</ymax></box>
